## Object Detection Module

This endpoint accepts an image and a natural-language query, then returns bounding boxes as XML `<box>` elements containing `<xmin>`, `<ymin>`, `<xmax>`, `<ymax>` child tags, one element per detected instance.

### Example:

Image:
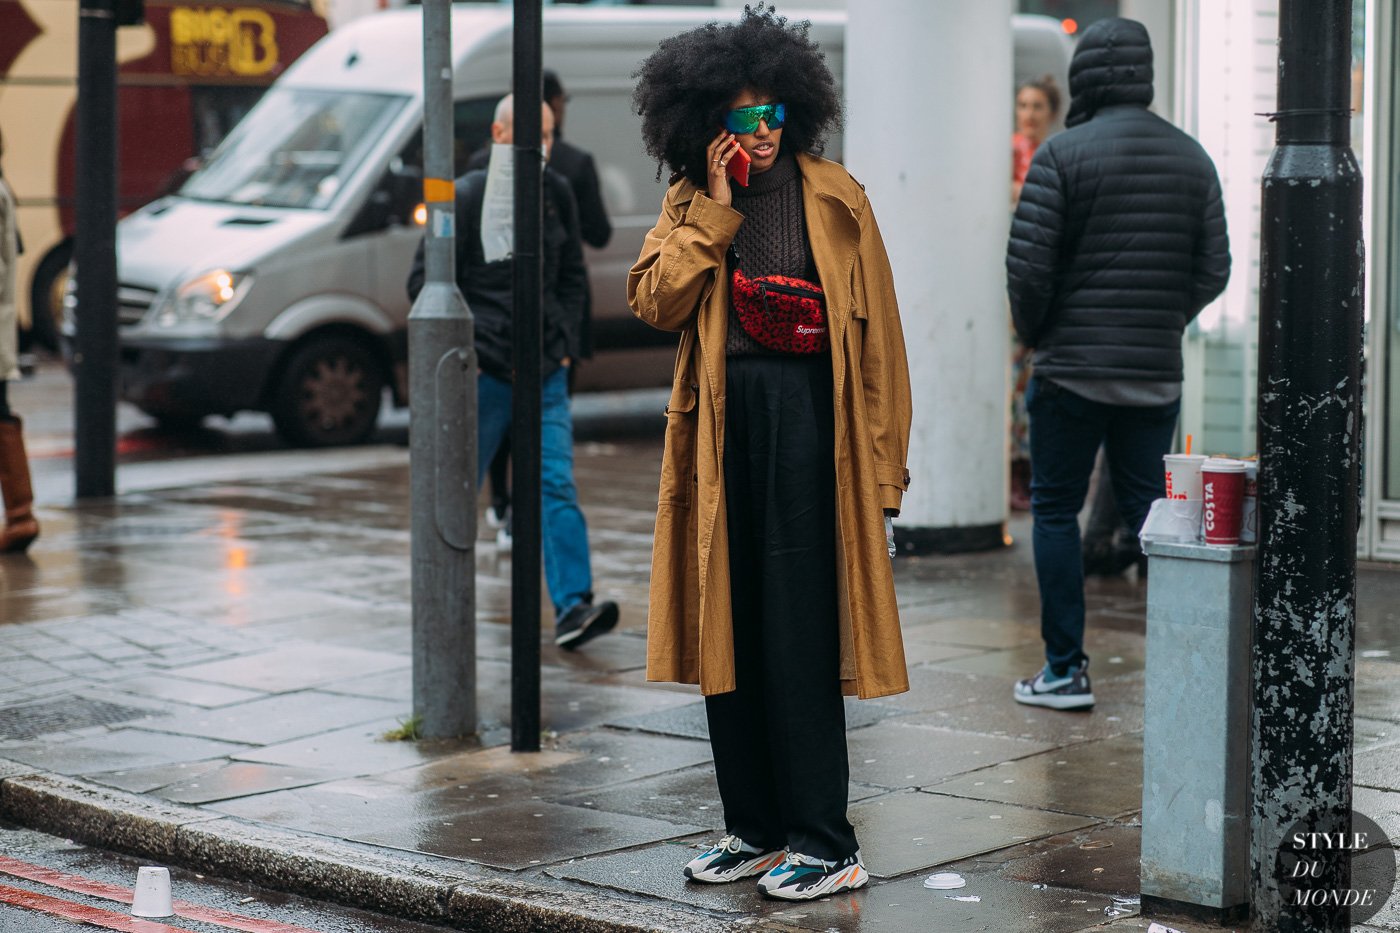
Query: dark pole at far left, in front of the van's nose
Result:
<box><xmin>73</xmin><ymin>0</ymin><xmax>118</xmax><ymax>499</ymax></box>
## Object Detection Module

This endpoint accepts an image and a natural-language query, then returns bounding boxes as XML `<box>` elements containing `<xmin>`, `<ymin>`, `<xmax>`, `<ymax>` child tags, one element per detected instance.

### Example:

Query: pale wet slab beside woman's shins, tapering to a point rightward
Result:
<box><xmin>847</xmin><ymin>723</ymin><xmax>1051</xmax><ymax>787</ymax></box>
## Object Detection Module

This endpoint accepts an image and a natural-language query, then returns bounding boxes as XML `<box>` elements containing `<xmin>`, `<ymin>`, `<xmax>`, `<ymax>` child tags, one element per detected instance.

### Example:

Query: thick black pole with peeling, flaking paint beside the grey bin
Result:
<box><xmin>1250</xmin><ymin>0</ymin><xmax>1362</xmax><ymax>933</ymax></box>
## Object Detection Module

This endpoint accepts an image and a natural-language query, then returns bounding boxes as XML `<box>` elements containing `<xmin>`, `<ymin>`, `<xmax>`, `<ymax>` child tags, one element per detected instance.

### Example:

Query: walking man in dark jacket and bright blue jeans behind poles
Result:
<box><xmin>407</xmin><ymin>97</ymin><xmax>617</xmax><ymax>650</ymax></box>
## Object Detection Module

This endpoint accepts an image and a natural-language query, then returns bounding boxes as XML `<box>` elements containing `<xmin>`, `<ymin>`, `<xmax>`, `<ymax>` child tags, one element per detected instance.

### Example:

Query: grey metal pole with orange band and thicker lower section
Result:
<box><xmin>409</xmin><ymin>0</ymin><xmax>476</xmax><ymax>738</ymax></box>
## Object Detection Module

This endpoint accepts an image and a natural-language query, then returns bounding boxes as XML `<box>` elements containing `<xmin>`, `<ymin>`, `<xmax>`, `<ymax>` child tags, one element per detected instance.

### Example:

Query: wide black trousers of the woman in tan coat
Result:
<box><xmin>706</xmin><ymin>353</ymin><xmax>857</xmax><ymax>859</ymax></box>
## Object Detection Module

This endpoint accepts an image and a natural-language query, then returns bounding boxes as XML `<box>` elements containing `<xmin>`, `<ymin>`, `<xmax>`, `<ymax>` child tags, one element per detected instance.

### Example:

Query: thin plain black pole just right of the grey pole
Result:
<box><xmin>511</xmin><ymin>0</ymin><xmax>543</xmax><ymax>751</ymax></box>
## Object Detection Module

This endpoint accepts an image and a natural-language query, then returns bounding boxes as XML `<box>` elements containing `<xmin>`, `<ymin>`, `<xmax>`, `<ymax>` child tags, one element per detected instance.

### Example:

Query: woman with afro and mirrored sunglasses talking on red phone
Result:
<box><xmin>627</xmin><ymin>6</ymin><xmax>911</xmax><ymax>899</ymax></box>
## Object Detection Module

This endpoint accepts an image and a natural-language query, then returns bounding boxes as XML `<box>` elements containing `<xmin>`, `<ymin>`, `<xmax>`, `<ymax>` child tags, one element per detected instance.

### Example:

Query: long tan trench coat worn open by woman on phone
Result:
<box><xmin>627</xmin><ymin>154</ymin><xmax>913</xmax><ymax>698</ymax></box>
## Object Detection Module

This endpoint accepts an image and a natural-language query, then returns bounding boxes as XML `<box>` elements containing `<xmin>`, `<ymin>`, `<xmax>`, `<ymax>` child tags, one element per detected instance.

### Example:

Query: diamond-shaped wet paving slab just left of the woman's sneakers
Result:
<box><xmin>349</xmin><ymin>800</ymin><xmax>703</xmax><ymax>871</ymax></box>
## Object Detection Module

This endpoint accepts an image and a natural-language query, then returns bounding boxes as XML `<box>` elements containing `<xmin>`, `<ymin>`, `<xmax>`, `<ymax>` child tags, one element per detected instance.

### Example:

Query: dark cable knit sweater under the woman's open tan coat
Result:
<box><xmin>724</xmin><ymin>154</ymin><xmax>818</xmax><ymax>356</ymax></box>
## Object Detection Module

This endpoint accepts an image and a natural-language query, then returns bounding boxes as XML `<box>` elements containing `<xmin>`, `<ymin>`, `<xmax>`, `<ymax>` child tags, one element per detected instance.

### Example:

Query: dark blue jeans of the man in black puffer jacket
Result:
<box><xmin>1026</xmin><ymin>375</ymin><xmax>1182</xmax><ymax>672</ymax></box>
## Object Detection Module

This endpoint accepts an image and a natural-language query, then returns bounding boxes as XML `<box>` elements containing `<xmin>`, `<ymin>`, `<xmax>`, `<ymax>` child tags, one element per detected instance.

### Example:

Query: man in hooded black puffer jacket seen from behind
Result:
<box><xmin>1007</xmin><ymin>18</ymin><xmax>1229</xmax><ymax>709</ymax></box>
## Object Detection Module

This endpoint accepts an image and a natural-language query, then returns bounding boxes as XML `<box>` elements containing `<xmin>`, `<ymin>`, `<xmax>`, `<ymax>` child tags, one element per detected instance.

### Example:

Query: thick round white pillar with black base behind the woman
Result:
<box><xmin>844</xmin><ymin>0</ymin><xmax>1012</xmax><ymax>553</ymax></box>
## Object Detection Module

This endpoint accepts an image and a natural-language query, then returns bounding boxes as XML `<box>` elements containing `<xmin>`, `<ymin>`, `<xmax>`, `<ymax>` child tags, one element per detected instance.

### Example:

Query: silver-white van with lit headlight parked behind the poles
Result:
<box><xmin>93</xmin><ymin>6</ymin><xmax>1070</xmax><ymax>445</ymax></box>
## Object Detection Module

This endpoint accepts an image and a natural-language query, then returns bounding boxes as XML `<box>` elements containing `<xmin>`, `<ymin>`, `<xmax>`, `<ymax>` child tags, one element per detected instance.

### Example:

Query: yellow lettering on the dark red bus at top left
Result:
<box><xmin>171</xmin><ymin>7</ymin><xmax>280</xmax><ymax>77</ymax></box>
